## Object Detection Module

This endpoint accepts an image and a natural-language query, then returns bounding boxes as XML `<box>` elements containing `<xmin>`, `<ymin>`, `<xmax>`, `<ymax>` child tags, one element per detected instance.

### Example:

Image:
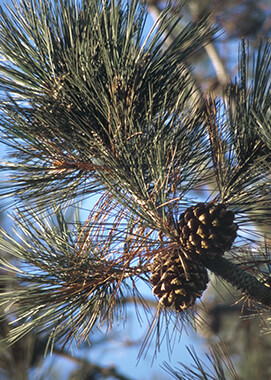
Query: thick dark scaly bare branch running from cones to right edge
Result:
<box><xmin>204</xmin><ymin>257</ymin><xmax>271</xmax><ymax>307</ymax></box>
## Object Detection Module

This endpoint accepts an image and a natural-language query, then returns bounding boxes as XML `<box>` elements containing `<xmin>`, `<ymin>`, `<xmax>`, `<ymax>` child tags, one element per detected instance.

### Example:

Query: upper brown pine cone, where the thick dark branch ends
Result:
<box><xmin>178</xmin><ymin>203</ymin><xmax>238</xmax><ymax>258</ymax></box>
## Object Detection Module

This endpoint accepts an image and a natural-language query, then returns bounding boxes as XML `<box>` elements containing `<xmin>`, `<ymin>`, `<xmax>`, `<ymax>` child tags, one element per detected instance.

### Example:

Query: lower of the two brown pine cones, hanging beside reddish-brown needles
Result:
<box><xmin>150</xmin><ymin>249</ymin><xmax>208</xmax><ymax>311</ymax></box>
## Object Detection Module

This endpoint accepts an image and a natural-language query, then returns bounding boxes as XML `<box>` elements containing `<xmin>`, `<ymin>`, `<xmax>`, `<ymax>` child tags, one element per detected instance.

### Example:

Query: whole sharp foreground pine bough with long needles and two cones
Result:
<box><xmin>0</xmin><ymin>0</ymin><xmax>271</xmax><ymax>378</ymax></box>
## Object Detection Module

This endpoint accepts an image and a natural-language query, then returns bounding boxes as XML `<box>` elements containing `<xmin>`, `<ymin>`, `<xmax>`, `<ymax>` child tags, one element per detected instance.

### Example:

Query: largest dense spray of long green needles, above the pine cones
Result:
<box><xmin>0</xmin><ymin>1</ymin><xmax>215</xmax><ymax>214</ymax></box>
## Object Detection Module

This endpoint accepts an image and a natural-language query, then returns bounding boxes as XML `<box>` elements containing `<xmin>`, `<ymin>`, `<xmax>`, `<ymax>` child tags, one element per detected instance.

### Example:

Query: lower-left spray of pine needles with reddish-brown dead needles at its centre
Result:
<box><xmin>0</xmin><ymin>197</ymin><xmax>154</xmax><ymax>347</ymax></box>
